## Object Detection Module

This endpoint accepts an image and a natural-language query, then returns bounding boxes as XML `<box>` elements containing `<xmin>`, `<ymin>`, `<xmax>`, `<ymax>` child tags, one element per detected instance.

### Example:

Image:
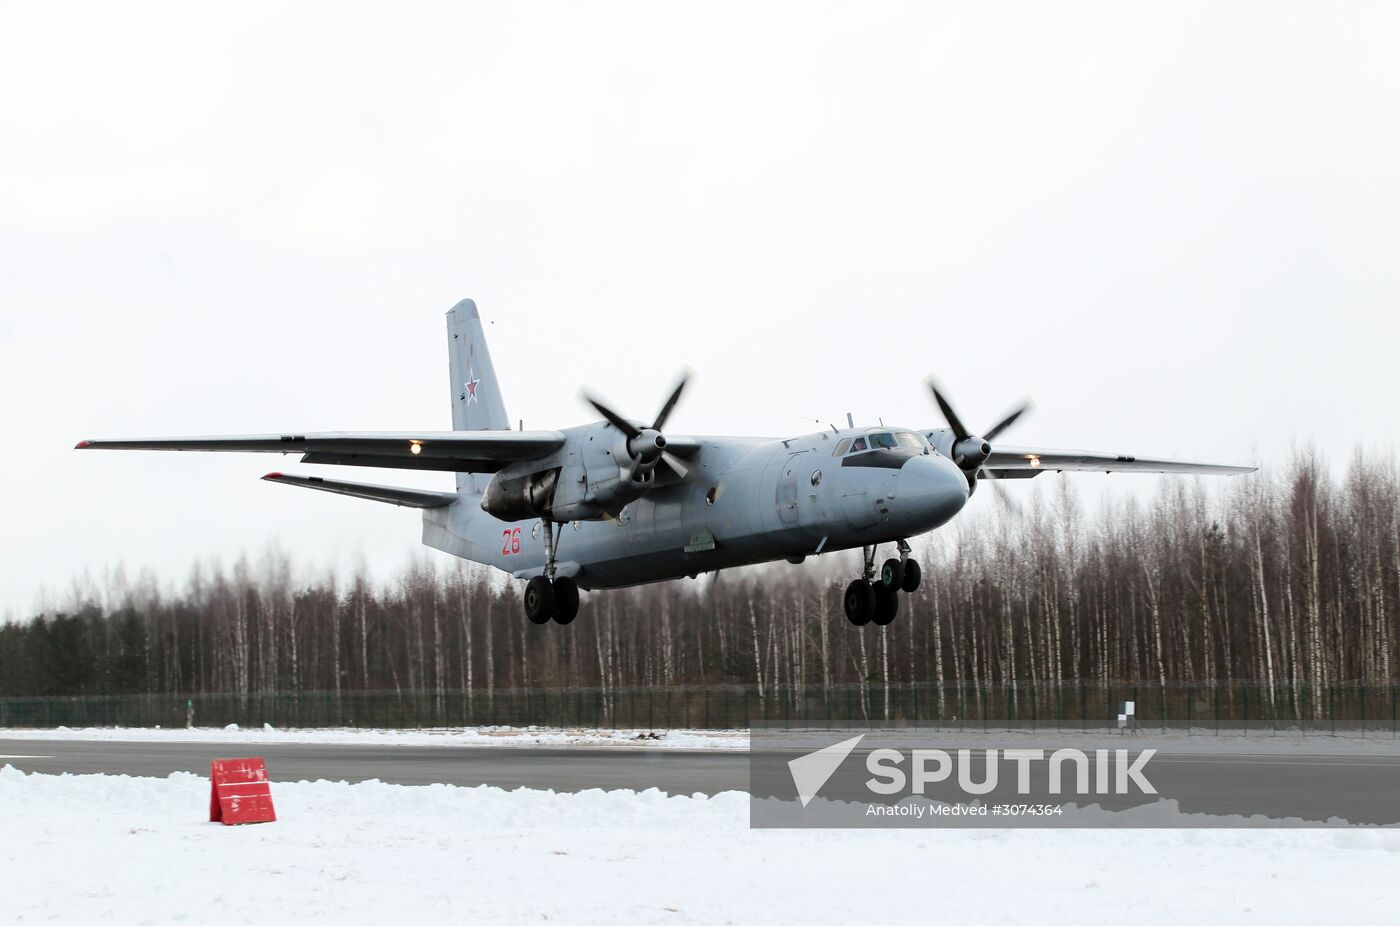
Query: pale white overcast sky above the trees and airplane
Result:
<box><xmin>0</xmin><ymin>3</ymin><xmax>1400</xmax><ymax>614</ymax></box>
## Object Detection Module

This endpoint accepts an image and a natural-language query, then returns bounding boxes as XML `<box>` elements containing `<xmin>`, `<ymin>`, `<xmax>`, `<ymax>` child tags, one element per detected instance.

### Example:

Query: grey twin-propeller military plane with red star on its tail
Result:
<box><xmin>77</xmin><ymin>298</ymin><xmax>1254</xmax><ymax>625</ymax></box>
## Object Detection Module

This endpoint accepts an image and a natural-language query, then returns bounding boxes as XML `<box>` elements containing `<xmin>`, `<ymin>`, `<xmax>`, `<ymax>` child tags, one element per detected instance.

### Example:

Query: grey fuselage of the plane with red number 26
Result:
<box><xmin>423</xmin><ymin>422</ymin><xmax>969</xmax><ymax>588</ymax></box>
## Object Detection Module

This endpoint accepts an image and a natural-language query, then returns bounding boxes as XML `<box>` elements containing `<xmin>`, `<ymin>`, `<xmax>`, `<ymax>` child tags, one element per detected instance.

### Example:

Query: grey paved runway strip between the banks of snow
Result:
<box><xmin>0</xmin><ymin>738</ymin><xmax>1400</xmax><ymax>824</ymax></box>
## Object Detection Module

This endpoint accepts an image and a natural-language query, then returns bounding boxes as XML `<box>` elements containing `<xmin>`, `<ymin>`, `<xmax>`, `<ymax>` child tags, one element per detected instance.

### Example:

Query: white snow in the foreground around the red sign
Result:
<box><xmin>0</xmin><ymin>766</ymin><xmax>1400</xmax><ymax>926</ymax></box>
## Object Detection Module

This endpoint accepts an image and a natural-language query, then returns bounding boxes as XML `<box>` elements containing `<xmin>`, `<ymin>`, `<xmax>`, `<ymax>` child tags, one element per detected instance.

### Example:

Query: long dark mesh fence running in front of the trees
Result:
<box><xmin>0</xmin><ymin>682</ymin><xmax>1400</xmax><ymax>737</ymax></box>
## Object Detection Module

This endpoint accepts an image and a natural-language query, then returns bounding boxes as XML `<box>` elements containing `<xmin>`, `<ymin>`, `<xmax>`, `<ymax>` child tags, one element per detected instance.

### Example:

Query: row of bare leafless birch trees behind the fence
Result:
<box><xmin>0</xmin><ymin>451</ymin><xmax>1400</xmax><ymax>722</ymax></box>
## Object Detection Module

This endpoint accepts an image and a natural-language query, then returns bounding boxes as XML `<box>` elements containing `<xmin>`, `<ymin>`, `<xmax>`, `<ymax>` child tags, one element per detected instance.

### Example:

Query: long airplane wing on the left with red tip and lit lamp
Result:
<box><xmin>76</xmin><ymin>430</ymin><xmax>564</xmax><ymax>472</ymax></box>
